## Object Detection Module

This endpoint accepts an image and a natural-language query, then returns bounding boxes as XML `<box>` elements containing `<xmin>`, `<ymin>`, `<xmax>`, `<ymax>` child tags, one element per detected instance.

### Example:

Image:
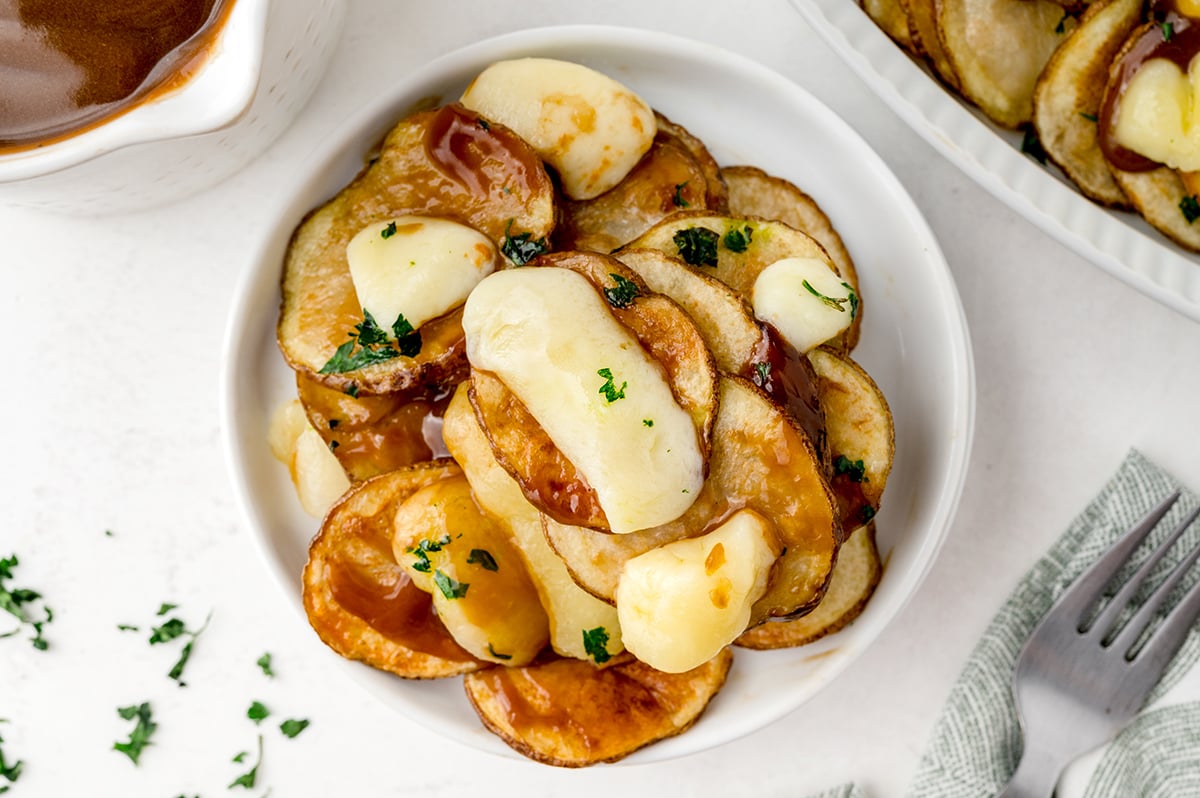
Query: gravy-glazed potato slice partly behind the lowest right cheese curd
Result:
<box><xmin>545</xmin><ymin>377</ymin><xmax>842</xmax><ymax>625</ymax></box>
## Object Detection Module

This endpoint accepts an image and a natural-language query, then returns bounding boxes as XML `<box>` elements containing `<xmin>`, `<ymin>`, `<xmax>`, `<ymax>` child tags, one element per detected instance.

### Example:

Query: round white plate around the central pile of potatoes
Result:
<box><xmin>221</xmin><ymin>26</ymin><xmax>974</xmax><ymax>763</ymax></box>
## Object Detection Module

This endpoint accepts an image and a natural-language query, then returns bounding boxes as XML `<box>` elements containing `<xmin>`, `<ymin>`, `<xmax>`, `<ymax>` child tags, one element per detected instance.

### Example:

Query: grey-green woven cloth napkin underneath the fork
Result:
<box><xmin>812</xmin><ymin>451</ymin><xmax>1200</xmax><ymax>798</ymax></box>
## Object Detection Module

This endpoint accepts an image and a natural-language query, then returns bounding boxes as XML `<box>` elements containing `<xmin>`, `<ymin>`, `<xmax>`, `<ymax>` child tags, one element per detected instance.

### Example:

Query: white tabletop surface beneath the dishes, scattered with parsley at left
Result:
<box><xmin>7</xmin><ymin>0</ymin><xmax>1200</xmax><ymax>798</ymax></box>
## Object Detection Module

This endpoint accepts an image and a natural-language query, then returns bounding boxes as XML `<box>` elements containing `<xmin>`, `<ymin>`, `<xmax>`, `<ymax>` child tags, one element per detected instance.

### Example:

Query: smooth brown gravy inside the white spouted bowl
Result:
<box><xmin>0</xmin><ymin>0</ymin><xmax>234</xmax><ymax>152</ymax></box>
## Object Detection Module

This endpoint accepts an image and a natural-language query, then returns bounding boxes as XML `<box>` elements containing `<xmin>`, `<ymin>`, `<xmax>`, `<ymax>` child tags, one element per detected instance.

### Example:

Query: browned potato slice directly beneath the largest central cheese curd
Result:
<box><xmin>469</xmin><ymin>252</ymin><xmax>716</xmax><ymax>529</ymax></box>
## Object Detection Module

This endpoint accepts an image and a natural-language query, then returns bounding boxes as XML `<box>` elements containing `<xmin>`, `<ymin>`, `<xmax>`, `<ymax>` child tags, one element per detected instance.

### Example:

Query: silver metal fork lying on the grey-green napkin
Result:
<box><xmin>997</xmin><ymin>484</ymin><xmax>1200</xmax><ymax>798</ymax></box>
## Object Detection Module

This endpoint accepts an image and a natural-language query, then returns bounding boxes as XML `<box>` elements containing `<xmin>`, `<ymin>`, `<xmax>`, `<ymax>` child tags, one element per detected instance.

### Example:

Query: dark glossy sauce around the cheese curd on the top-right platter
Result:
<box><xmin>1098</xmin><ymin>0</ymin><xmax>1200</xmax><ymax>172</ymax></box>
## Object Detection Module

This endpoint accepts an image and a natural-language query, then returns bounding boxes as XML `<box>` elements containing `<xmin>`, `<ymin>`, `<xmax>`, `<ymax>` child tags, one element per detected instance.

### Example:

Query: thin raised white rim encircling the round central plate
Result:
<box><xmin>218</xmin><ymin>24</ymin><xmax>976</xmax><ymax>764</ymax></box>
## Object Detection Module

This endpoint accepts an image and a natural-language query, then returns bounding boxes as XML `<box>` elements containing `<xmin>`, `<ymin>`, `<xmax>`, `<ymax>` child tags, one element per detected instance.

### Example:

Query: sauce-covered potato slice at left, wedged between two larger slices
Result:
<box><xmin>296</xmin><ymin>371</ymin><xmax>448</xmax><ymax>482</ymax></box>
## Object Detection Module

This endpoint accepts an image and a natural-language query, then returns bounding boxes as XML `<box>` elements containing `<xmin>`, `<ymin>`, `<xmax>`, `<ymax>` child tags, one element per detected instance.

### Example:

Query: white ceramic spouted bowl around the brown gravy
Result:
<box><xmin>0</xmin><ymin>0</ymin><xmax>346</xmax><ymax>215</ymax></box>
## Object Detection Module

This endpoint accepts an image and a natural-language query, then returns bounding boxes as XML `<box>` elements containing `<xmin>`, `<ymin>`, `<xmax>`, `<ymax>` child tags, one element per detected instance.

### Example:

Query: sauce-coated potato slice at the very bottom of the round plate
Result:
<box><xmin>463</xmin><ymin>648</ymin><xmax>733</xmax><ymax>768</ymax></box>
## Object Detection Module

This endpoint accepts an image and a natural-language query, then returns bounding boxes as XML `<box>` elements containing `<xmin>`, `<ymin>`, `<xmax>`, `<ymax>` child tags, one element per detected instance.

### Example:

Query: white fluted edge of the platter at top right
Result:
<box><xmin>790</xmin><ymin>0</ymin><xmax>1200</xmax><ymax>320</ymax></box>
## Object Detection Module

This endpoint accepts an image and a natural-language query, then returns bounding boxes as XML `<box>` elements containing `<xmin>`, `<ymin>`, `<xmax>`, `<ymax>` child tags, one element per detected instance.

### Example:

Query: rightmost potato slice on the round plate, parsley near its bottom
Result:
<box><xmin>809</xmin><ymin>348</ymin><xmax>895</xmax><ymax>529</ymax></box>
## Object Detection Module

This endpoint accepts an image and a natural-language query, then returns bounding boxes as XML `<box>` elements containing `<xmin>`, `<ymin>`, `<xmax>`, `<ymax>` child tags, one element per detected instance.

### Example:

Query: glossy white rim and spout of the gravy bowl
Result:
<box><xmin>0</xmin><ymin>0</ymin><xmax>265</xmax><ymax>184</ymax></box>
